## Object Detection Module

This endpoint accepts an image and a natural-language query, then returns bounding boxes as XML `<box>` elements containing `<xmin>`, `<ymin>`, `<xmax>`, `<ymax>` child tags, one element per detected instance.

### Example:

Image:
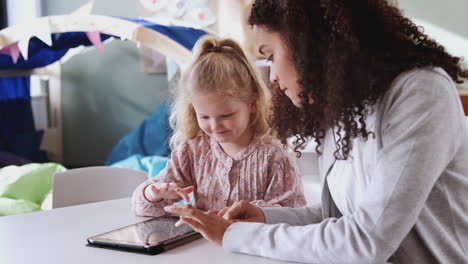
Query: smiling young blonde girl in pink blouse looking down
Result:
<box><xmin>133</xmin><ymin>36</ymin><xmax>306</xmax><ymax>216</ymax></box>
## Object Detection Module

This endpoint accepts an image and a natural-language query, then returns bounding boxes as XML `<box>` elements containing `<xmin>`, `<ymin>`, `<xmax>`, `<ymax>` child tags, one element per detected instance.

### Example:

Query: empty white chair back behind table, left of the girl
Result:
<box><xmin>52</xmin><ymin>166</ymin><xmax>147</xmax><ymax>208</ymax></box>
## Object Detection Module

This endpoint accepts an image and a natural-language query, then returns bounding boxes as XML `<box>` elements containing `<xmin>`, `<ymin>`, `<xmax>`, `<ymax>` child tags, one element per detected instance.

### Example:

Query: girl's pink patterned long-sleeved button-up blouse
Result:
<box><xmin>132</xmin><ymin>136</ymin><xmax>306</xmax><ymax>216</ymax></box>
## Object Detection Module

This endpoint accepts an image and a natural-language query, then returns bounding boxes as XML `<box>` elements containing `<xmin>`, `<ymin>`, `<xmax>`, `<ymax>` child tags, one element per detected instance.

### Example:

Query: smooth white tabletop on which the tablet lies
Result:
<box><xmin>0</xmin><ymin>198</ymin><xmax>292</xmax><ymax>264</ymax></box>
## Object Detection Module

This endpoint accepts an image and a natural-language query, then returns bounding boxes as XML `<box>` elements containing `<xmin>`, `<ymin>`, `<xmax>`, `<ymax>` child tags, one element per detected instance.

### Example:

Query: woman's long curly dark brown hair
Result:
<box><xmin>249</xmin><ymin>0</ymin><xmax>468</xmax><ymax>159</ymax></box>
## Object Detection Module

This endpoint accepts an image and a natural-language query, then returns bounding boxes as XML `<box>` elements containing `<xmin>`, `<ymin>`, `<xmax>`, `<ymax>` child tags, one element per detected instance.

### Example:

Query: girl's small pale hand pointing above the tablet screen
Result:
<box><xmin>145</xmin><ymin>182</ymin><xmax>195</xmax><ymax>203</ymax></box>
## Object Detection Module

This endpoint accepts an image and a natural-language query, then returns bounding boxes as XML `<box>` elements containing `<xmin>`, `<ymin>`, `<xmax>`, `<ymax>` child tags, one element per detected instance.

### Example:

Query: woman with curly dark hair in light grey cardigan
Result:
<box><xmin>167</xmin><ymin>0</ymin><xmax>468</xmax><ymax>263</ymax></box>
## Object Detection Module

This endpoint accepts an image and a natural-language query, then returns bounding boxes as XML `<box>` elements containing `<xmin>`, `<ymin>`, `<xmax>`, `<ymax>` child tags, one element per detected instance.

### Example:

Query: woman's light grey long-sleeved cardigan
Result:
<box><xmin>223</xmin><ymin>68</ymin><xmax>468</xmax><ymax>264</ymax></box>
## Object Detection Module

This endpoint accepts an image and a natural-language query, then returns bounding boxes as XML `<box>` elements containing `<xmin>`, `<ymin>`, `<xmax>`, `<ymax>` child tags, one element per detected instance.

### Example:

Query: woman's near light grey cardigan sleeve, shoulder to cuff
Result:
<box><xmin>223</xmin><ymin>71</ymin><xmax>464</xmax><ymax>263</ymax></box>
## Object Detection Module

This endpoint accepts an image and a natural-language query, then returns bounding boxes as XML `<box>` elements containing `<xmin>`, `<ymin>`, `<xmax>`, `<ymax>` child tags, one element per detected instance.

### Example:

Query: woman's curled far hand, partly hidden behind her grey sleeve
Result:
<box><xmin>216</xmin><ymin>200</ymin><xmax>266</xmax><ymax>223</ymax></box>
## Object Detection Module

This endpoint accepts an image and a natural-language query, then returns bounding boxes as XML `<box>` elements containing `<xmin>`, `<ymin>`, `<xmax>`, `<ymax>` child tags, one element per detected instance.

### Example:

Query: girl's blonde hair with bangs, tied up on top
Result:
<box><xmin>169</xmin><ymin>36</ymin><xmax>274</xmax><ymax>149</ymax></box>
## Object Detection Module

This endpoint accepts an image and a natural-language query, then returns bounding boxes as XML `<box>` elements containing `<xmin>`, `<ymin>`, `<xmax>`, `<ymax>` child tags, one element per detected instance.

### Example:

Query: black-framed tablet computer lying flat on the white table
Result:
<box><xmin>88</xmin><ymin>216</ymin><xmax>201</xmax><ymax>255</ymax></box>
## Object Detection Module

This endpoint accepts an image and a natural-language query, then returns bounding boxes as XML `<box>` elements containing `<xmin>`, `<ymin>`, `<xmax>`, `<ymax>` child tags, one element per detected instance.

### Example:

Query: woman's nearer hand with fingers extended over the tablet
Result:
<box><xmin>164</xmin><ymin>204</ymin><xmax>232</xmax><ymax>246</ymax></box>
